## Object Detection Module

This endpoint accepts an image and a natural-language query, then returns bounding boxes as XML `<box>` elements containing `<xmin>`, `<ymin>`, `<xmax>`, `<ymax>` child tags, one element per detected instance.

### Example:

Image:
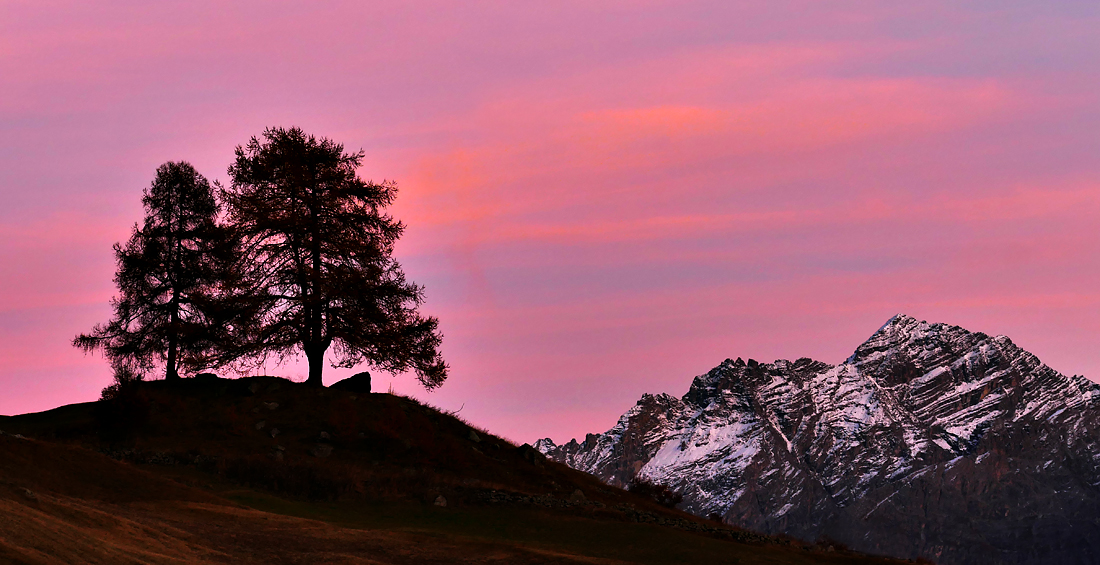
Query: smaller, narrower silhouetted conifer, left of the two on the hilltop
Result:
<box><xmin>73</xmin><ymin>162</ymin><xmax>226</xmax><ymax>380</ymax></box>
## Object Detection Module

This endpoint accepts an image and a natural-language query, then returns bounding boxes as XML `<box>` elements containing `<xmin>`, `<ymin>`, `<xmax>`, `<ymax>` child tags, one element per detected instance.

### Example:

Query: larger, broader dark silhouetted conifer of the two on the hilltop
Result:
<box><xmin>222</xmin><ymin>128</ymin><xmax>448</xmax><ymax>389</ymax></box>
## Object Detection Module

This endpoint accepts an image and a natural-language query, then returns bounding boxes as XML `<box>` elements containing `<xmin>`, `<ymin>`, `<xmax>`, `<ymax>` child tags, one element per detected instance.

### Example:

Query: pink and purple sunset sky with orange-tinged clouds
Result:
<box><xmin>0</xmin><ymin>0</ymin><xmax>1100</xmax><ymax>442</ymax></box>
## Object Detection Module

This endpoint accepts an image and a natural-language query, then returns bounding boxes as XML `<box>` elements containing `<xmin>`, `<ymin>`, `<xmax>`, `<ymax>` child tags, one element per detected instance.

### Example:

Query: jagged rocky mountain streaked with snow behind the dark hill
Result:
<box><xmin>536</xmin><ymin>315</ymin><xmax>1100</xmax><ymax>564</ymax></box>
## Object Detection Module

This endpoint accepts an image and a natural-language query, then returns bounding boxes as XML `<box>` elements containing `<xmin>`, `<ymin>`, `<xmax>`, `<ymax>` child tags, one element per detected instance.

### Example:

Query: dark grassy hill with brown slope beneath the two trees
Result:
<box><xmin>0</xmin><ymin>377</ymin><xmax>898</xmax><ymax>564</ymax></box>
